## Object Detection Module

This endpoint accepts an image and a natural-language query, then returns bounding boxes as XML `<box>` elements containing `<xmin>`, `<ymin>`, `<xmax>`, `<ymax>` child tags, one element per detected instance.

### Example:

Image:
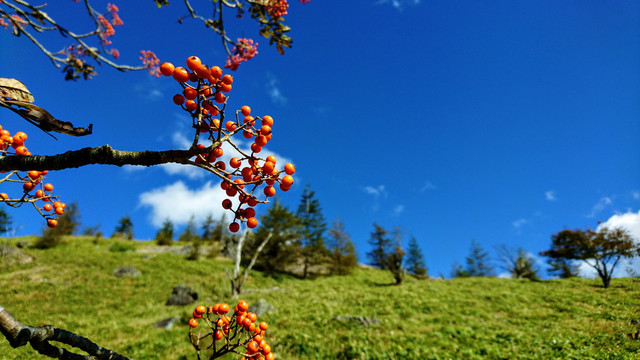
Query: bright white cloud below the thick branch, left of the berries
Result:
<box><xmin>139</xmin><ymin>181</ymin><xmax>227</xmax><ymax>227</ymax></box>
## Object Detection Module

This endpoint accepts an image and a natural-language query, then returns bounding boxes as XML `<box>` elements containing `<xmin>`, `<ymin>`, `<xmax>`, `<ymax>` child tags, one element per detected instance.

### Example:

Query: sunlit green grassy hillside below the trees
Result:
<box><xmin>0</xmin><ymin>237</ymin><xmax>640</xmax><ymax>360</ymax></box>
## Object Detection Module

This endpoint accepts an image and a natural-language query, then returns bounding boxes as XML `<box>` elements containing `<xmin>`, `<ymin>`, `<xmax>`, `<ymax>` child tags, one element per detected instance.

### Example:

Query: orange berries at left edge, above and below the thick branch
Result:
<box><xmin>0</xmin><ymin>125</ymin><xmax>66</xmax><ymax>227</ymax></box>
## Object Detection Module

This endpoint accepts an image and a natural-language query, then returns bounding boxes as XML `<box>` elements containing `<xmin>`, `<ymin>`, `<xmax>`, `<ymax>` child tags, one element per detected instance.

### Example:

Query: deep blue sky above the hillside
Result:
<box><xmin>0</xmin><ymin>0</ymin><xmax>640</xmax><ymax>276</ymax></box>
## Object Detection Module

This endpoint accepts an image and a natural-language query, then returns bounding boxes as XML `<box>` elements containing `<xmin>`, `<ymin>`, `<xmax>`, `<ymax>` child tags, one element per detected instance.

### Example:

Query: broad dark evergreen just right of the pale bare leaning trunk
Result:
<box><xmin>248</xmin><ymin>199</ymin><xmax>300</xmax><ymax>272</ymax></box>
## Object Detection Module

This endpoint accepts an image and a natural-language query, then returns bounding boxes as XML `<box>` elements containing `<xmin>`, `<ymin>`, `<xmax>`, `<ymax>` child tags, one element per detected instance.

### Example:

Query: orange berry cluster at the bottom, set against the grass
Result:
<box><xmin>189</xmin><ymin>300</ymin><xmax>275</xmax><ymax>360</ymax></box>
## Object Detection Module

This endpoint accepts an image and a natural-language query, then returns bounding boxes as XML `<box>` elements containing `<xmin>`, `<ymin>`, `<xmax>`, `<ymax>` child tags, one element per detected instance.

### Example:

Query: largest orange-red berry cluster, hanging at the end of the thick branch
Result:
<box><xmin>160</xmin><ymin>56</ymin><xmax>295</xmax><ymax>233</ymax></box>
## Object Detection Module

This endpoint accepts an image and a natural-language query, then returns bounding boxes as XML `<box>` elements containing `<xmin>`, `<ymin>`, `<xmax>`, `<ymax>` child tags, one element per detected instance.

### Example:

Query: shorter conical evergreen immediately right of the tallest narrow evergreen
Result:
<box><xmin>327</xmin><ymin>219</ymin><xmax>358</xmax><ymax>275</ymax></box>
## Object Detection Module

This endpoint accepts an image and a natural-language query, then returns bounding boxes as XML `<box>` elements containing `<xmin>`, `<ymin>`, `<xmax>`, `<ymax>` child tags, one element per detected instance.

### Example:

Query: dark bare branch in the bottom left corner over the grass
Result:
<box><xmin>0</xmin><ymin>305</ymin><xmax>131</xmax><ymax>360</ymax></box>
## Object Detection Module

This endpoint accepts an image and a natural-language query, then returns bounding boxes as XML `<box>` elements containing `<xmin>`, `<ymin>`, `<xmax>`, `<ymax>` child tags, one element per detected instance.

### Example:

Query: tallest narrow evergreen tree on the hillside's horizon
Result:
<box><xmin>296</xmin><ymin>185</ymin><xmax>328</xmax><ymax>278</ymax></box>
